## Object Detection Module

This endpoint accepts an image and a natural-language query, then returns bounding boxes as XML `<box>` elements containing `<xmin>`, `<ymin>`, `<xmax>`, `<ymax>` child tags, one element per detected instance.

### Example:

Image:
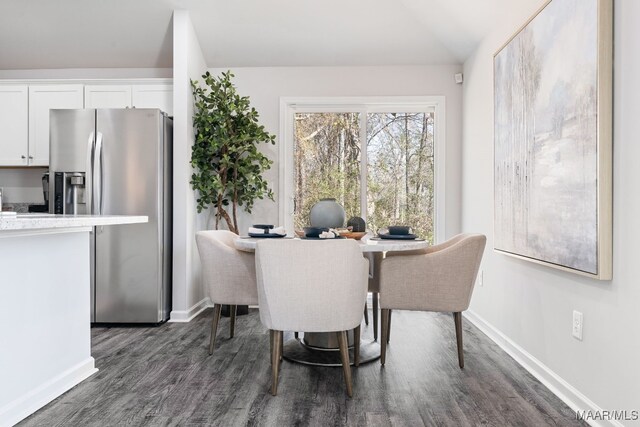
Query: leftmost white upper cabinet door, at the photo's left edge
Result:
<box><xmin>0</xmin><ymin>85</ymin><xmax>29</xmax><ymax>166</ymax></box>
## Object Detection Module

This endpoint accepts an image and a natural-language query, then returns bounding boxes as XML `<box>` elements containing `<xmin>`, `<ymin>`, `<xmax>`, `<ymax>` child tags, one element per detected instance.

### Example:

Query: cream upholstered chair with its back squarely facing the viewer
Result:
<box><xmin>256</xmin><ymin>239</ymin><xmax>369</xmax><ymax>397</ymax></box>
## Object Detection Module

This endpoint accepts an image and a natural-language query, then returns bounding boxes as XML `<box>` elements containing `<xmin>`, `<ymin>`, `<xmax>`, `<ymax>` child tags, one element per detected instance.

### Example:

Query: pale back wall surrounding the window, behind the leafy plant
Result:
<box><xmin>209</xmin><ymin>65</ymin><xmax>462</xmax><ymax>236</ymax></box>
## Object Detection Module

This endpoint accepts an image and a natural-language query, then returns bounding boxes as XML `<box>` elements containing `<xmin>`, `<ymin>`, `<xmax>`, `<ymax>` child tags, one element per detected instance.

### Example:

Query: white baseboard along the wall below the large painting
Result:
<box><xmin>463</xmin><ymin>310</ymin><xmax>622</xmax><ymax>427</ymax></box>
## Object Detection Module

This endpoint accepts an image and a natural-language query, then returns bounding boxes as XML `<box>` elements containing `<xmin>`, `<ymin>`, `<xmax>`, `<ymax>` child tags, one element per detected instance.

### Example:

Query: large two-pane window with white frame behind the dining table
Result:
<box><xmin>280</xmin><ymin>97</ymin><xmax>444</xmax><ymax>242</ymax></box>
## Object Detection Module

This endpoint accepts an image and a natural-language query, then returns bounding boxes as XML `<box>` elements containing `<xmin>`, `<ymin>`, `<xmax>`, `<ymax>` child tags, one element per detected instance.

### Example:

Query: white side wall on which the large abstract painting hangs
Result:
<box><xmin>462</xmin><ymin>0</ymin><xmax>640</xmax><ymax>424</ymax></box>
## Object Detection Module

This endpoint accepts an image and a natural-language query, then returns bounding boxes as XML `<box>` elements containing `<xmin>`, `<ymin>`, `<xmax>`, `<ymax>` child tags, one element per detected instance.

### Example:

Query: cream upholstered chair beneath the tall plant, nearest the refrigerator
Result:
<box><xmin>196</xmin><ymin>230</ymin><xmax>258</xmax><ymax>354</ymax></box>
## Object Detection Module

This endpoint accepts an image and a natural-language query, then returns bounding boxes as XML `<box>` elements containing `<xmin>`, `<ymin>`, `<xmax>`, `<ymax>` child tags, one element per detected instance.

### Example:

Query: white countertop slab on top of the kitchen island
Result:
<box><xmin>0</xmin><ymin>214</ymin><xmax>149</xmax><ymax>231</ymax></box>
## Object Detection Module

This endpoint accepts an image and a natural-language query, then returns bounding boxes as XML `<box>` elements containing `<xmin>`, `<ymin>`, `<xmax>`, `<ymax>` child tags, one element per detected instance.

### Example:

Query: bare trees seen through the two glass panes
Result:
<box><xmin>294</xmin><ymin>112</ymin><xmax>434</xmax><ymax>242</ymax></box>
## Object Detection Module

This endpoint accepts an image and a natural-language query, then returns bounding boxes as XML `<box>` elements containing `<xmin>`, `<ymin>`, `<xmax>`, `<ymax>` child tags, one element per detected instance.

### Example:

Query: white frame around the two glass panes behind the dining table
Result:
<box><xmin>278</xmin><ymin>96</ymin><xmax>446</xmax><ymax>243</ymax></box>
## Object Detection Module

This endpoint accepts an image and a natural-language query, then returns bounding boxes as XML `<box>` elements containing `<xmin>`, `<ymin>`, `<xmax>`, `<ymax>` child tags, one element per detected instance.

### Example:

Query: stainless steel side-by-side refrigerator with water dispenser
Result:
<box><xmin>49</xmin><ymin>109</ymin><xmax>173</xmax><ymax>323</ymax></box>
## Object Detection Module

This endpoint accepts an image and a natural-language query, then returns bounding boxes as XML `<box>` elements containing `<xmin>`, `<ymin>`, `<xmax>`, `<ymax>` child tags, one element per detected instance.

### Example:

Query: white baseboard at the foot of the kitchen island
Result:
<box><xmin>0</xmin><ymin>357</ymin><xmax>98</xmax><ymax>426</ymax></box>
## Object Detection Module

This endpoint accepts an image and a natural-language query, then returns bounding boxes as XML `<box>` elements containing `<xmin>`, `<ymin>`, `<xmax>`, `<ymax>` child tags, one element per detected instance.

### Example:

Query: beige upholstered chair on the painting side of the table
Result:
<box><xmin>380</xmin><ymin>234</ymin><xmax>487</xmax><ymax>368</ymax></box>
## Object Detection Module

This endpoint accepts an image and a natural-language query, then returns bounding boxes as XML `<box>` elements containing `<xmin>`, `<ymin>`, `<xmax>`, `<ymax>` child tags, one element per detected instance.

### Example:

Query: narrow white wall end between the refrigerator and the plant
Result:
<box><xmin>171</xmin><ymin>10</ymin><xmax>207</xmax><ymax>321</ymax></box>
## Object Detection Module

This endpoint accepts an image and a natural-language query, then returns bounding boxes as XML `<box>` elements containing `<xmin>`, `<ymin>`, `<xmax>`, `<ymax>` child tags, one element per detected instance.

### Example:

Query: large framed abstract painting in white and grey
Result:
<box><xmin>494</xmin><ymin>0</ymin><xmax>613</xmax><ymax>280</ymax></box>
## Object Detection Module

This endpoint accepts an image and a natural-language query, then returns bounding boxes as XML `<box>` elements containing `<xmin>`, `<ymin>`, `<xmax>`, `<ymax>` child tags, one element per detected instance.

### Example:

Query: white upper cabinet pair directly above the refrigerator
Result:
<box><xmin>84</xmin><ymin>84</ymin><xmax>173</xmax><ymax>116</ymax></box>
